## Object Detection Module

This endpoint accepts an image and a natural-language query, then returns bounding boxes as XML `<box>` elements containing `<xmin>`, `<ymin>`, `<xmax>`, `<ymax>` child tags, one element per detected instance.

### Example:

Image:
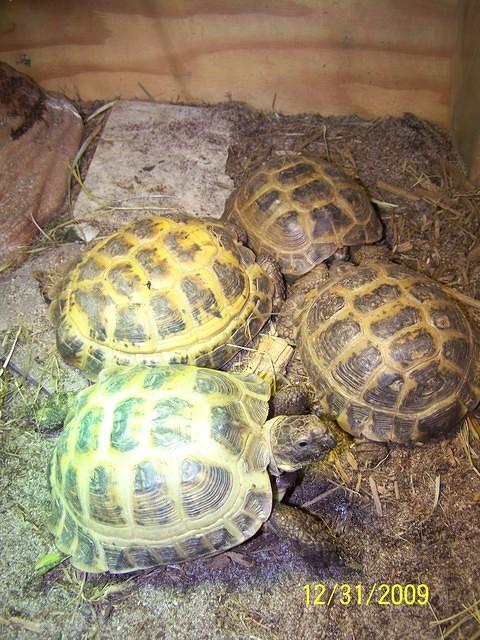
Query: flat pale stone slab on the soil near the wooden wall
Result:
<box><xmin>73</xmin><ymin>101</ymin><xmax>233</xmax><ymax>239</ymax></box>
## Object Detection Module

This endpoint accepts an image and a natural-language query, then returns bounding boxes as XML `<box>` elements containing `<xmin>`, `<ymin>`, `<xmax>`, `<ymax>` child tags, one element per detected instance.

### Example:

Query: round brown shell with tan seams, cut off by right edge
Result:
<box><xmin>298</xmin><ymin>263</ymin><xmax>480</xmax><ymax>442</ymax></box>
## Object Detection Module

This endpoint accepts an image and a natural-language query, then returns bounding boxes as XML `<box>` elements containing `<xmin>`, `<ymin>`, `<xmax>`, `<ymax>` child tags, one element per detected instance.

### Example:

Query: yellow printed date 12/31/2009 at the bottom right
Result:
<box><xmin>303</xmin><ymin>582</ymin><xmax>430</xmax><ymax>607</ymax></box>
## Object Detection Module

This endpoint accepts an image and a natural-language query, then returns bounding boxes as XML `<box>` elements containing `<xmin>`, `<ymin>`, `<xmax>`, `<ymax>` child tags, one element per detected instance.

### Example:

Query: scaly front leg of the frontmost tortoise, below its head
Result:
<box><xmin>265</xmin><ymin>503</ymin><xmax>345</xmax><ymax>567</ymax></box>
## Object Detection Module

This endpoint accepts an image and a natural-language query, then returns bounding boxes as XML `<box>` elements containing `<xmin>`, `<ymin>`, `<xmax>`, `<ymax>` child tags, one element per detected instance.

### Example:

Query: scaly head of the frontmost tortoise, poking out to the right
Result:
<box><xmin>265</xmin><ymin>415</ymin><xmax>337</xmax><ymax>475</ymax></box>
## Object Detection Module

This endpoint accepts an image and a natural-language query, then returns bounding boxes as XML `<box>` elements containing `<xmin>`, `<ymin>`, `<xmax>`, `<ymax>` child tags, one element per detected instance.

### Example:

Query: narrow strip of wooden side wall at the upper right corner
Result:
<box><xmin>453</xmin><ymin>0</ymin><xmax>480</xmax><ymax>182</ymax></box>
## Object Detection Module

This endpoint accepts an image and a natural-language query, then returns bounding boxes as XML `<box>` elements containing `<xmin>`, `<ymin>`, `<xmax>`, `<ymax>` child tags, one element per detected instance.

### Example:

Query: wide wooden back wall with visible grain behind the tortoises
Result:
<box><xmin>0</xmin><ymin>0</ymin><xmax>462</xmax><ymax>124</ymax></box>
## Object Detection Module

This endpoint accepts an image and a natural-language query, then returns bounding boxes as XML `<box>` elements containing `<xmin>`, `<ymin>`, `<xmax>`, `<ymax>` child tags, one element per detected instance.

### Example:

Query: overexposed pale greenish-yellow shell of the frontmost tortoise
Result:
<box><xmin>49</xmin><ymin>365</ymin><xmax>272</xmax><ymax>573</ymax></box>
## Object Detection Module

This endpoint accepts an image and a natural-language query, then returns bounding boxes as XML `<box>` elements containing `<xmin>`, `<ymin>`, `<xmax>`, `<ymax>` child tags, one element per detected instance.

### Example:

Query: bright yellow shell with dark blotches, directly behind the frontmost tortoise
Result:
<box><xmin>51</xmin><ymin>216</ymin><xmax>273</xmax><ymax>379</ymax></box>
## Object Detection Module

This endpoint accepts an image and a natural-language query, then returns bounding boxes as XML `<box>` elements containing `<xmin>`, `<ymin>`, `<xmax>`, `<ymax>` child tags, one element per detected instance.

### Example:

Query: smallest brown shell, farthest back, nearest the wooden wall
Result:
<box><xmin>224</xmin><ymin>154</ymin><xmax>382</xmax><ymax>277</ymax></box>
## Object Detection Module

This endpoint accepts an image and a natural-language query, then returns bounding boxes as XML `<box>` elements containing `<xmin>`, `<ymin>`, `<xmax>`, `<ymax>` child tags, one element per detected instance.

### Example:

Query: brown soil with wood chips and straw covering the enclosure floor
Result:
<box><xmin>0</xmin><ymin>103</ymin><xmax>480</xmax><ymax>640</ymax></box>
